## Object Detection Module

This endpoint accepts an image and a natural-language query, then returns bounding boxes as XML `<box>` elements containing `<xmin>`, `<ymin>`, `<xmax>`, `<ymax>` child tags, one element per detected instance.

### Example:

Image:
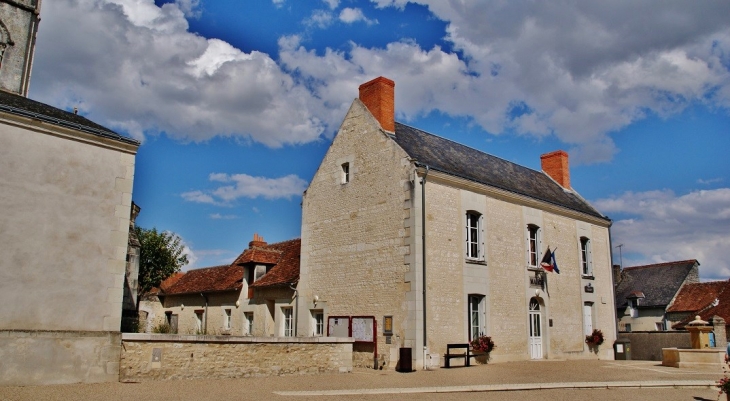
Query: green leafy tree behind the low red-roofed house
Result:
<box><xmin>134</xmin><ymin>227</ymin><xmax>188</xmax><ymax>294</ymax></box>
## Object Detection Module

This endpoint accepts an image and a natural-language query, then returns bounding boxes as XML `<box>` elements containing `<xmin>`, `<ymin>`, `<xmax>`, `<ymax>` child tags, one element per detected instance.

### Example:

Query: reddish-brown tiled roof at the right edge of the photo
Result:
<box><xmin>667</xmin><ymin>281</ymin><xmax>730</xmax><ymax>329</ymax></box>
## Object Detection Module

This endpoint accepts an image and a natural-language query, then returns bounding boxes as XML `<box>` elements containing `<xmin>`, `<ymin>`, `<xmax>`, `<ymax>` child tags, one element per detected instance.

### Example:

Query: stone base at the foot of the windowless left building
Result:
<box><xmin>0</xmin><ymin>330</ymin><xmax>121</xmax><ymax>386</ymax></box>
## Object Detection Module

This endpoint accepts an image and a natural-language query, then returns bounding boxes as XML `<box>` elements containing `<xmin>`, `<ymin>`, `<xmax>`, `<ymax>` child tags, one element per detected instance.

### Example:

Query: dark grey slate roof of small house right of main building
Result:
<box><xmin>616</xmin><ymin>259</ymin><xmax>699</xmax><ymax>309</ymax></box>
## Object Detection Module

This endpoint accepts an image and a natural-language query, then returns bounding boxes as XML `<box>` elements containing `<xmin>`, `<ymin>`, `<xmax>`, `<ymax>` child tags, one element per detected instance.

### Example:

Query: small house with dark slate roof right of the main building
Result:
<box><xmin>616</xmin><ymin>259</ymin><xmax>700</xmax><ymax>332</ymax></box>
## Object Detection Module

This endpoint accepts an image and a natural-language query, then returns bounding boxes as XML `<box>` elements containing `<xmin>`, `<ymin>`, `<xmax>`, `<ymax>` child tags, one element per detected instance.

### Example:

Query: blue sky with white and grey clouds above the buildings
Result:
<box><xmin>30</xmin><ymin>0</ymin><xmax>730</xmax><ymax>280</ymax></box>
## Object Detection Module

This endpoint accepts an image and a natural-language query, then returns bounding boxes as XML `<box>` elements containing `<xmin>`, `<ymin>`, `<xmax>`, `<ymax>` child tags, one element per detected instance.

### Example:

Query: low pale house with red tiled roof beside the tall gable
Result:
<box><xmin>146</xmin><ymin>235</ymin><xmax>301</xmax><ymax>337</ymax></box>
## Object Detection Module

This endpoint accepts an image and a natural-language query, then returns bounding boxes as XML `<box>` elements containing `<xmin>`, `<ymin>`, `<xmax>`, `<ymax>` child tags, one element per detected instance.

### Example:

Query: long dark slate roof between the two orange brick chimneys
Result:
<box><xmin>393</xmin><ymin>122</ymin><xmax>609</xmax><ymax>220</ymax></box>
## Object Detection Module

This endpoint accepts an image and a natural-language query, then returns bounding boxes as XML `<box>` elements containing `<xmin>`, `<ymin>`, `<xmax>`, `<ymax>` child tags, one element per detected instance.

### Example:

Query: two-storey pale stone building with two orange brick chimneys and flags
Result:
<box><xmin>298</xmin><ymin>77</ymin><xmax>616</xmax><ymax>368</ymax></box>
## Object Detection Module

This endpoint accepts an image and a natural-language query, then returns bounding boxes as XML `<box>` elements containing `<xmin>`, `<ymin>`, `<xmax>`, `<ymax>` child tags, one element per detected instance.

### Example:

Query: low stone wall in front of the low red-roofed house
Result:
<box><xmin>119</xmin><ymin>333</ymin><xmax>353</xmax><ymax>382</ymax></box>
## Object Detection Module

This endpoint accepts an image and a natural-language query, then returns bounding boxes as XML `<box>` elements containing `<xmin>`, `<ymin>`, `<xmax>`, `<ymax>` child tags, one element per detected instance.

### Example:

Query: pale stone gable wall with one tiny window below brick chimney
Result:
<box><xmin>298</xmin><ymin>100</ymin><xmax>411</xmax><ymax>366</ymax></box>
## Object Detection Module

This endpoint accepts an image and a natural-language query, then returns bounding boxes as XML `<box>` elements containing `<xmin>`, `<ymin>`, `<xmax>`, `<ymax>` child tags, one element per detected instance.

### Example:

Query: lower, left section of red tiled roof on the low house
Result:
<box><xmin>163</xmin><ymin>265</ymin><xmax>243</xmax><ymax>295</ymax></box>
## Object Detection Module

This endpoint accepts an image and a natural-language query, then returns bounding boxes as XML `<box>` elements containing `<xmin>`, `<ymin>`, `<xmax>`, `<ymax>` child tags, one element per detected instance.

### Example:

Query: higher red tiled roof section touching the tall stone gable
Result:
<box><xmin>246</xmin><ymin>238</ymin><xmax>302</xmax><ymax>288</ymax></box>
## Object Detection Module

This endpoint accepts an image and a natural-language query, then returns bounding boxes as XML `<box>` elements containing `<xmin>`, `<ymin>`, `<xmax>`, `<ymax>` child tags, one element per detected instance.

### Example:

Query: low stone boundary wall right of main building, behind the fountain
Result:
<box><xmin>618</xmin><ymin>331</ymin><xmax>692</xmax><ymax>361</ymax></box>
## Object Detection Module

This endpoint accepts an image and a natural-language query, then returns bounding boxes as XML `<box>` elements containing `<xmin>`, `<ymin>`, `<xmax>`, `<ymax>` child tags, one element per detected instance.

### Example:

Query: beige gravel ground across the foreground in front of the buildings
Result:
<box><xmin>0</xmin><ymin>361</ymin><xmax>722</xmax><ymax>401</ymax></box>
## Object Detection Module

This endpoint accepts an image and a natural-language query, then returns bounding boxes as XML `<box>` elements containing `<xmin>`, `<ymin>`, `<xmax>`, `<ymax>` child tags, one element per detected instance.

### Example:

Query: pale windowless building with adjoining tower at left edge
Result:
<box><xmin>0</xmin><ymin>0</ymin><xmax>139</xmax><ymax>385</ymax></box>
